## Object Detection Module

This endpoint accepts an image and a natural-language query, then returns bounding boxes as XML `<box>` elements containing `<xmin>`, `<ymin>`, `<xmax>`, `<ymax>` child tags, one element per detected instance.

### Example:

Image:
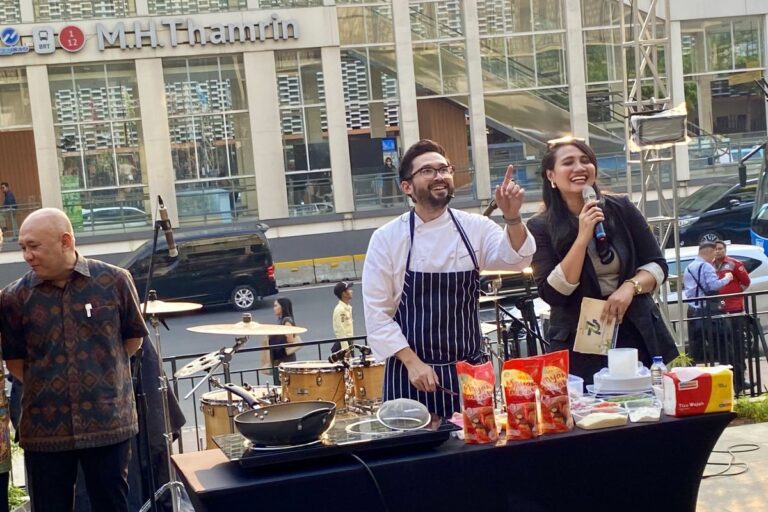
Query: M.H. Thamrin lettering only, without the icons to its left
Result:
<box><xmin>96</xmin><ymin>14</ymin><xmax>299</xmax><ymax>50</ymax></box>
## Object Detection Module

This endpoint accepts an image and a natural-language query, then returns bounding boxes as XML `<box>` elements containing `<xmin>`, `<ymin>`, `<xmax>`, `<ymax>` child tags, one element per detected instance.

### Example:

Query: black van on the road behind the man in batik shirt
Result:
<box><xmin>120</xmin><ymin>224</ymin><xmax>277</xmax><ymax>311</ymax></box>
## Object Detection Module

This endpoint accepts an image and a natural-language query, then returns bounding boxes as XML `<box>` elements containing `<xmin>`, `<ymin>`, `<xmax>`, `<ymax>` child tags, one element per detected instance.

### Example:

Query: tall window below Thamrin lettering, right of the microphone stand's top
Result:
<box><xmin>163</xmin><ymin>55</ymin><xmax>258</xmax><ymax>225</ymax></box>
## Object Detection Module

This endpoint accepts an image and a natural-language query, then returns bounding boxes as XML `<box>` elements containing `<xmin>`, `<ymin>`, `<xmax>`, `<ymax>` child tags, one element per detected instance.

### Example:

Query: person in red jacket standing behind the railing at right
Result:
<box><xmin>713</xmin><ymin>240</ymin><xmax>751</xmax><ymax>394</ymax></box>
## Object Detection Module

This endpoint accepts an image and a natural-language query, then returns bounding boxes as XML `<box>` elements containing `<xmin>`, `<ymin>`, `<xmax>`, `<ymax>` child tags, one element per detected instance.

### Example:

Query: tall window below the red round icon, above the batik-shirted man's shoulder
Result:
<box><xmin>48</xmin><ymin>62</ymin><xmax>150</xmax><ymax>231</ymax></box>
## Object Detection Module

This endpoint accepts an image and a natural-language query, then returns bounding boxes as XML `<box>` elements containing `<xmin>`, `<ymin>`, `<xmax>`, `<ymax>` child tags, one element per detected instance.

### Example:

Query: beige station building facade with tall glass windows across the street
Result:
<box><xmin>0</xmin><ymin>0</ymin><xmax>768</xmax><ymax>255</ymax></box>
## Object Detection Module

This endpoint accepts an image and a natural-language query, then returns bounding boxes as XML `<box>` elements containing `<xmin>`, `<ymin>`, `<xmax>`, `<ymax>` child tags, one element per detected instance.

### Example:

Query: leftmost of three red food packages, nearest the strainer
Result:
<box><xmin>456</xmin><ymin>361</ymin><xmax>499</xmax><ymax>444</ymax></box>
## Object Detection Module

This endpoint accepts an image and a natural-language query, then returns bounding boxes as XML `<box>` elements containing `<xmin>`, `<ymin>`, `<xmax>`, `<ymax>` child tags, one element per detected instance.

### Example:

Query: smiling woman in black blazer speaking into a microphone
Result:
<box><xmin>528</xmin><ymin>137</ymin><xmax>678</xmax><ymax>384</ymax></box>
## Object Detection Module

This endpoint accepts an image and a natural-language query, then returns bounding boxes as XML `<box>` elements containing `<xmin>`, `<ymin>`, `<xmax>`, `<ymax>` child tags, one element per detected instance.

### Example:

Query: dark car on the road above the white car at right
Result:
<box><xmin>667</xmin><ymin>178</ymin><xmax>757</xmax><ymax>247</ymax></box>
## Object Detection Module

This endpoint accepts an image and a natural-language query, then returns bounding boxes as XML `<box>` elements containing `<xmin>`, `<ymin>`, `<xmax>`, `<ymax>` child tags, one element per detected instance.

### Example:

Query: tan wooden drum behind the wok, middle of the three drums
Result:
<box><xmin>278</xmin><ymin>361</ymin><xmax>346</xmax><ymax>409</ymax></box>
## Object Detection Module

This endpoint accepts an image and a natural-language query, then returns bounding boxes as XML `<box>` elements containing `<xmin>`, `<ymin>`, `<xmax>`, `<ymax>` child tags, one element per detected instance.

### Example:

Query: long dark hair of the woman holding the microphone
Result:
<box><xmin>541</xmin><ymin>139</ymin><xmax>607</xmax><ymax>255</ymax></box>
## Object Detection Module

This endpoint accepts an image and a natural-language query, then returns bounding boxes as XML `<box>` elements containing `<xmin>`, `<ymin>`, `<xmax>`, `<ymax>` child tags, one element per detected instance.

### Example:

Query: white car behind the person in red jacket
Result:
<box><xmin>664</xmin><ymin>244</ymin><xmax>768</xmax><ymax>322</ymax></box>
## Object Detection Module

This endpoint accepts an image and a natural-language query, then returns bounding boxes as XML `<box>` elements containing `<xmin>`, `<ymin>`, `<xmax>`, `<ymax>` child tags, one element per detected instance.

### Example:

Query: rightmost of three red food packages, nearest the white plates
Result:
<box><xmin>539</xmin><ymin>350</ymin><xmax>573</xmax><ymax>434</ymax></box>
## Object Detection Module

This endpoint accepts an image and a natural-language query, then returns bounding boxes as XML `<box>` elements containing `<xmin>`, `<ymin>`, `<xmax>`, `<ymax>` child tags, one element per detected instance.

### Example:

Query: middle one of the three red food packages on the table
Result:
<box><xmin>501</xmin><ymin>357</ymin><xmax>542</xmax><ymax>439</ymax></box>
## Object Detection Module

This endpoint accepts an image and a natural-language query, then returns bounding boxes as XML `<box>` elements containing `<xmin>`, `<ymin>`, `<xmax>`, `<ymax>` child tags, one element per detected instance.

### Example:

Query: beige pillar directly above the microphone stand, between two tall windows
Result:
<box><xmin>136</xmin><ymin>59</ymin><xmax>179</xmax><ymax>222</ymax></box>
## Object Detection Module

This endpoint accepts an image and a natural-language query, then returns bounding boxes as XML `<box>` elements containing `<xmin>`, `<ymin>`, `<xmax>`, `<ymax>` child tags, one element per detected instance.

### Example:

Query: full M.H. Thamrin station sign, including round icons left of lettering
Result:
<box><xmin>20</xmin><ymin>14</ymin><xmax>299</xmax><ymax>55</ymax></box>
